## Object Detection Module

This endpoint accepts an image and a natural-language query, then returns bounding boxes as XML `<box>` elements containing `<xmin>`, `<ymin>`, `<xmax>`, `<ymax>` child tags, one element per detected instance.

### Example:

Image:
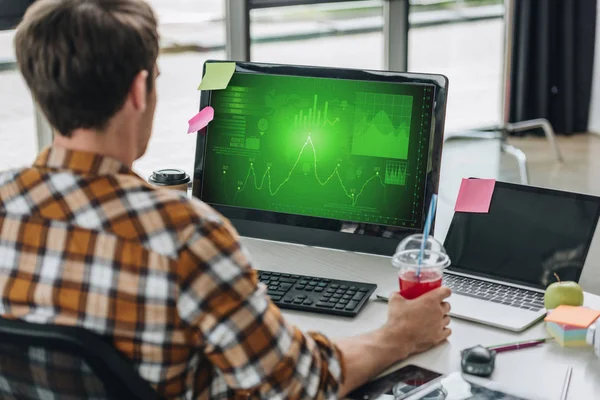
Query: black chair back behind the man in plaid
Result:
<box><xmin>0</xmin><ymin>318</ymin><xmax>158</xmax><ymax>400</ymax></box>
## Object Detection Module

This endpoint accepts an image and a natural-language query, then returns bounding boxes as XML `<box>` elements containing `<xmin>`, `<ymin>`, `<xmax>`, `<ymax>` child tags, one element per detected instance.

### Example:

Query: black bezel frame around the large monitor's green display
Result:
<box><xmin>192</xmin><ymin>60</ymin><xmax>448</xmax><ymax>256</ymax></box>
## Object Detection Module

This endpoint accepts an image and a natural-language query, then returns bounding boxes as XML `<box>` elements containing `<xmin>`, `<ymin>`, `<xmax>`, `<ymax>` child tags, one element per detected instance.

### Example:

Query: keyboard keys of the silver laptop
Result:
<box><xmin>444</xmin><ymin>274</ymin><xmax>544</xmax><ymax>311</ymax></box>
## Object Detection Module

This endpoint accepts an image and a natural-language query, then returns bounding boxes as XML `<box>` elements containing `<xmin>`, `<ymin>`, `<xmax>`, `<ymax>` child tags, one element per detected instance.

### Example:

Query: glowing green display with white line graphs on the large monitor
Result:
<box><xmin>202</xmin><ymin>73</ymin><xmax>433</xmax><ymax>227</ymax></box>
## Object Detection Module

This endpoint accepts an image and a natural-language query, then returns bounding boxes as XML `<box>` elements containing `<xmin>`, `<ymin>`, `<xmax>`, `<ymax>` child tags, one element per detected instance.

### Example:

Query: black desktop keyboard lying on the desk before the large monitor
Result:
<box><xmin>258</xmin><ymin>271</ymin><xmax>377</xmax><ymax>317</ymax></box>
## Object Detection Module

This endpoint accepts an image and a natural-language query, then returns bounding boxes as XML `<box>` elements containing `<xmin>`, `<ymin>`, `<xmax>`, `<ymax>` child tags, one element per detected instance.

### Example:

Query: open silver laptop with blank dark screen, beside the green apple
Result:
<box><xmin>444</xmin><ymin>182</ymin><xmax>600</xmax><ymax>332</ymax></box>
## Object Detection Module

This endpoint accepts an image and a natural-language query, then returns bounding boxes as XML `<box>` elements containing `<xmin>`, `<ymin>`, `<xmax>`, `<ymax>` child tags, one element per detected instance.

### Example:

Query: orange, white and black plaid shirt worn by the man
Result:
<box><xmin>0</xmin><ymin>147</ymin><xmax>343</xmax><ymax>399</ymax></box>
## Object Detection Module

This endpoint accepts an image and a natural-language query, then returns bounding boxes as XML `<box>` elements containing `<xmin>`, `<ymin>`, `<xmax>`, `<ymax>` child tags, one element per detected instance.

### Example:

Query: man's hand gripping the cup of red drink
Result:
<box><xmin>383</xmin><ymin>287</ymin><xmax>452</xmax><ymax>361</ymax></box>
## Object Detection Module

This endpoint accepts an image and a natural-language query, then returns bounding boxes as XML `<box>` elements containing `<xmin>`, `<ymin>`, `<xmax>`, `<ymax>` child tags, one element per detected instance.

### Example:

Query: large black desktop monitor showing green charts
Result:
<box><xmin>193</xmin><ymin>61</ymin><xmax>448</xmax><ymax>255</ymax></box>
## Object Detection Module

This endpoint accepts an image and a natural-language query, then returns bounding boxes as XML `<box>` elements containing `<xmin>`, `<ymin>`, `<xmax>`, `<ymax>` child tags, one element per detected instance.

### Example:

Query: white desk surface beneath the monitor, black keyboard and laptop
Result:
<box><xmin>243</xmin><ymin>239</ymin><xmax>600</xmax><ymax>400</ymax></box>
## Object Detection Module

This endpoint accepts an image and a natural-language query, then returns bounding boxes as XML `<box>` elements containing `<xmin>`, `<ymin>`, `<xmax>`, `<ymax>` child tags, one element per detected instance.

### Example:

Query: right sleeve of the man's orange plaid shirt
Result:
<box><xmin>177</xmin><ymin>219</ymin><xmax>344</xmax><ymax>399</ymax></box>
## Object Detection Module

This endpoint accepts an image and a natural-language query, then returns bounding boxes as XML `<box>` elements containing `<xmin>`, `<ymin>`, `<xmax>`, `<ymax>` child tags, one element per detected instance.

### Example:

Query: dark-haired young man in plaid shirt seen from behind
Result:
<box><xmin>0</xmin><ymin>0</ymin><xmax>450</xmax><ymax>399</ymax></box>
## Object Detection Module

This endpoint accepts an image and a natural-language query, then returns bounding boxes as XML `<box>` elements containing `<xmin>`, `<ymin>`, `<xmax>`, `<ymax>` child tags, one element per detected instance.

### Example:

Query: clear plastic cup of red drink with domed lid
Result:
<box><xmin>392</xmin><ymin>235</ymin><xmax>450</xmax><ymax>299</ymax></box>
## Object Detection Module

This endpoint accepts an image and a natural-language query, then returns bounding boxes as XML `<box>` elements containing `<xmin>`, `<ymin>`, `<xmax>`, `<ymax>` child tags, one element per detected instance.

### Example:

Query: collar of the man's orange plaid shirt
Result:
<box><xmin>33</xmin><ymin>147</ymin><xmax>135</xmax><ymax>175</ymax></box>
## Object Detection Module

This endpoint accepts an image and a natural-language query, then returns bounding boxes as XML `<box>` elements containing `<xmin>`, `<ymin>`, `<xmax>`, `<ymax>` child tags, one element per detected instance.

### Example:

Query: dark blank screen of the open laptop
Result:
<box><xmin>444</xmin><ymin>182</ymin><xmax>600</xmax><ymax>289</ymax></box>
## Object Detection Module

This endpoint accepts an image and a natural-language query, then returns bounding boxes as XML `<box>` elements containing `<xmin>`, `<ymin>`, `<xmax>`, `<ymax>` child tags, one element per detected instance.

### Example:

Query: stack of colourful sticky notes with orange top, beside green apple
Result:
<box><xmin>545</xmin><ymin>306</ymin><xmax>600</xmax><ymax>347</ymax></box>
